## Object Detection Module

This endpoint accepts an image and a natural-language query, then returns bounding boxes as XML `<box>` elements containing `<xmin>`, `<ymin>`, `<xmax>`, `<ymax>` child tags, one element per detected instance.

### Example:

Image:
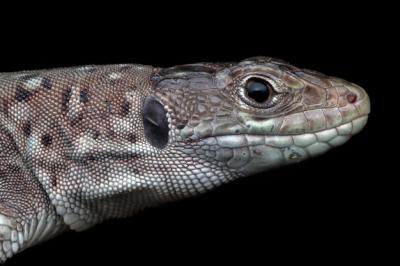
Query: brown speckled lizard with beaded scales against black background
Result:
<box><xmin>0</xmin><ymin>57</ymin><xmax>370</xmax><ymax>262</ymax></box>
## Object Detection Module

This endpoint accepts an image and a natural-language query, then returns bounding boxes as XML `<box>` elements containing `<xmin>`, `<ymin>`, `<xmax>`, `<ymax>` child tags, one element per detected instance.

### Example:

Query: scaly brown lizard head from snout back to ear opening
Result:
<box><xmin>144</xmin><ymin>57</ymin><xmax>370</xmax><ymax>183</ymax></box>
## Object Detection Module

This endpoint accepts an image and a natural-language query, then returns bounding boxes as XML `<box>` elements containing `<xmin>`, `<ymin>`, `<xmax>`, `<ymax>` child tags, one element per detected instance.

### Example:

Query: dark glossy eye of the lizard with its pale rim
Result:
<box><xmin>239</xmin><ymin>77</ymin><xmax>283</xmax><ymax>108</ymax></box>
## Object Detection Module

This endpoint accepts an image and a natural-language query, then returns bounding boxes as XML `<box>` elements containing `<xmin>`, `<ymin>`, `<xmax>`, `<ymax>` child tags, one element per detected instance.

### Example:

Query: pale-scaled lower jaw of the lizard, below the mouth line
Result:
<box><xmin>184</xmin><ymin>115</ymin><xmax>368</xmax><ymax>174</ymax></box>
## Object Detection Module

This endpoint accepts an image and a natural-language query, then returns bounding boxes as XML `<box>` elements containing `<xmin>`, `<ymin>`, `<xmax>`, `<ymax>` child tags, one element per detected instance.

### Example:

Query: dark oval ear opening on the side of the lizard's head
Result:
<box><xmin>142</xmin><ymin>97</ymin><xmax>169</xmax><ymax>149</ymax></box>
